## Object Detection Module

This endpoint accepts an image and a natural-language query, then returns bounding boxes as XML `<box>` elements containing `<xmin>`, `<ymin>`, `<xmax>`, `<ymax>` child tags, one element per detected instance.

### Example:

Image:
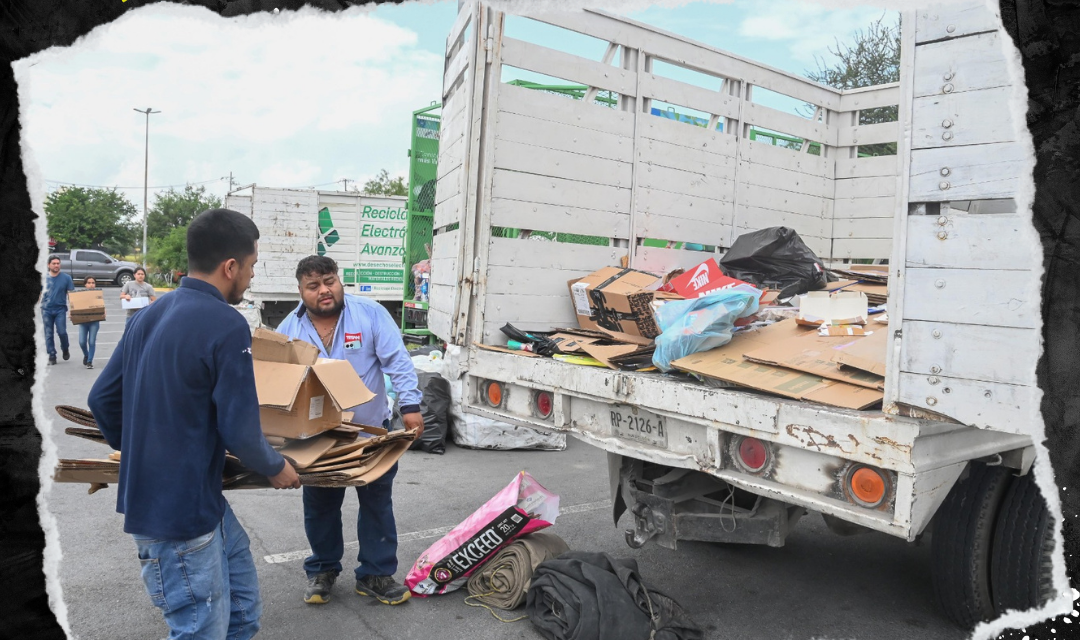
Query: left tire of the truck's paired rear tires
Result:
<box><xmin>930</xmin><ymin>462</ymin><xmax>1012</xmax><ymax>628</ymax></box>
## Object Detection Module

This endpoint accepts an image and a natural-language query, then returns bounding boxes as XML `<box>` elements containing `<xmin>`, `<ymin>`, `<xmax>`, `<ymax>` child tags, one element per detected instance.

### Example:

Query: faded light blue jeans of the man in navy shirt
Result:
<box><xmin>132</xmin><ymin>503</ymin><xmax>262</xmax><ymax>640</ymax></box>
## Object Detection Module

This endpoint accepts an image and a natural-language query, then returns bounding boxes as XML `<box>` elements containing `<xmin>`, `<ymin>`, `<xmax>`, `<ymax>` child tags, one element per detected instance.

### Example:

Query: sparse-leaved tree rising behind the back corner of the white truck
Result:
<box><xmin>805</xmin><ymin>14</ymin><xmax>900</xmax><ymax>155</ymax></box>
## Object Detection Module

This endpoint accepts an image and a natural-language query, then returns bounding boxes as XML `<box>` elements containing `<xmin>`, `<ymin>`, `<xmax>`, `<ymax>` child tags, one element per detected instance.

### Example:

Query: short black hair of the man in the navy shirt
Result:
<box><xmin>188</xmin><ymin>209</ymin><xmax>259</xmax><ymax>273</ymax></box>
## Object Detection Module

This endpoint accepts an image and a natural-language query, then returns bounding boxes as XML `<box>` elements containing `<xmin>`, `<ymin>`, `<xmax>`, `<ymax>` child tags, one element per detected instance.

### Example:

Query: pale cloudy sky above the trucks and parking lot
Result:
<box><xmin>14</xmin><ymin>0</ymin><xmax>895</xmax><ymax>207</ymax></box>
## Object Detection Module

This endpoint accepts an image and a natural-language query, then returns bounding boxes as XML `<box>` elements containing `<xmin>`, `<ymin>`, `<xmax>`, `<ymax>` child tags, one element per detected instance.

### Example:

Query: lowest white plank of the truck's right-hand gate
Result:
<box><xmin>897</xmin><ymin>369</ymin><xmax>1041</xmax><ymax>434</ymax></box>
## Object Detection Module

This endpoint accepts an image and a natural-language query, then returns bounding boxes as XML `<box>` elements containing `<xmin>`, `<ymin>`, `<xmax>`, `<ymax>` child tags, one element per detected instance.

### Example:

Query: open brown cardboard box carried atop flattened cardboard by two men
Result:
<box><xmin>252</xmin><ymin>327</ymin><xmax>375</xmax><ymax>438</ymax></box>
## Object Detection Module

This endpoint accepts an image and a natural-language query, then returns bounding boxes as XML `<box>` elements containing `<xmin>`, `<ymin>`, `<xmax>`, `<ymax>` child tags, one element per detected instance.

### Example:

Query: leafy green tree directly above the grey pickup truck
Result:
<box><xmin>45</xmin><ymin>187</ymin><xmax>138</xmax><ymax>255</ymax></box>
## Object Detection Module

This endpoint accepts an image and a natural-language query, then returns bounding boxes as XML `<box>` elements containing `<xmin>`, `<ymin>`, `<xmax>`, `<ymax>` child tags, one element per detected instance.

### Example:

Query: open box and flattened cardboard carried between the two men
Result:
<box><xmin>53</xmin><ymin>329</ymin><xmax>416</xmax><ymax>493</ymax></box>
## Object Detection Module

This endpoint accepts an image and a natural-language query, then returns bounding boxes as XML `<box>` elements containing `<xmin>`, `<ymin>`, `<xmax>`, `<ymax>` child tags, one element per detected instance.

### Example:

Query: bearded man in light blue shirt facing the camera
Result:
<box><xmin>278</xmin><ymin>256</ymin><xmax>423</xmax><ymax>604</ymax></box>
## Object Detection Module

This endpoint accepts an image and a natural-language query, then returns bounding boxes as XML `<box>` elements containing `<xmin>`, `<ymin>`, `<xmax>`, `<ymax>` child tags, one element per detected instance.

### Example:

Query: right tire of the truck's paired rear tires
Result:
<box><xmin>990</xmin><ymin>473</ymin><xmax>1054</xmax><ymax>613</ymax></box>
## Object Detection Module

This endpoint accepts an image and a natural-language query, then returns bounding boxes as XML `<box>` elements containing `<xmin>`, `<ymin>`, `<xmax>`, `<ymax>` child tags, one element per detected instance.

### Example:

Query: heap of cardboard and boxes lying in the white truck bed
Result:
<box><xmin>476</xmin><ymin>252</ymin><xmax>889</xmax><ymax>409</ymax></box>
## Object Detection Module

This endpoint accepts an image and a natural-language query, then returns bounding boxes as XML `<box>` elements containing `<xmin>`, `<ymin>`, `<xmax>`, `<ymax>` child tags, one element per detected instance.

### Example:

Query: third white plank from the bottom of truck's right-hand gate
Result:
<box><xmin>904</xmin><ymin>268</ymin><xmax>1040</xmax><ymax>329</ymax></box>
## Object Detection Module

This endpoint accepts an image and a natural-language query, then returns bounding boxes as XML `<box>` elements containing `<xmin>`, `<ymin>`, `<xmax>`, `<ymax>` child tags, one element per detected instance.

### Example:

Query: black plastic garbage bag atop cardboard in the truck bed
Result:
<box><xmin>720</xmin><ymin>227</ymin><xmax>829</xmax><ymax>299</ymax></box>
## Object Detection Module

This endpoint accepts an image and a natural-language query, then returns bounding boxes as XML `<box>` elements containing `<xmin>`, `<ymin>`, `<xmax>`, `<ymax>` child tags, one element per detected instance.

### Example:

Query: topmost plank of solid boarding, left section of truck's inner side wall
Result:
<box><xmin>499</xmin><ymin>84</ymin><xmax>634</xmax><ymax>138</ymax></box>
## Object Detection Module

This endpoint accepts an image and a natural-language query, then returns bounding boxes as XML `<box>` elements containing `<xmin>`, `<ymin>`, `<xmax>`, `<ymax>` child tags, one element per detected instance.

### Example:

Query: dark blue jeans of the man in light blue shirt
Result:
<box><xmin>303</xmin><ymin>464</ymin><xmax>397</xmax><ymax>580</ymax></box>
